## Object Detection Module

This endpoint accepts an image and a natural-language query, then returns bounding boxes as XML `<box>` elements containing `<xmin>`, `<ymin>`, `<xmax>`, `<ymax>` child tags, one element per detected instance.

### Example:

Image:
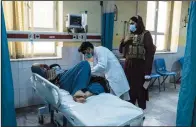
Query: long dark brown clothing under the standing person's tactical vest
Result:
<box><xmin>119</xmin><ymin>32</ymin><xmax>156</xmax><ymax>109</ymax></box>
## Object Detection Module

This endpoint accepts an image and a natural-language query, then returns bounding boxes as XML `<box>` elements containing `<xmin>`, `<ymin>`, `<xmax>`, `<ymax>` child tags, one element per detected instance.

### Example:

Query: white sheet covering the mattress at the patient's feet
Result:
<box><xmin>56</xmin><ymin>90</ymin><xmax>143</xmax><ymax>126</ymax></box>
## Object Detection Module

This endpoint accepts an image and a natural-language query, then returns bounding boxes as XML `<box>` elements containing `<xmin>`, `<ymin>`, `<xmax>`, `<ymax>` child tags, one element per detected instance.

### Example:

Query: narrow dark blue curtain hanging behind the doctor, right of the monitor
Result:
<box><xmin>101</xmin><ymin>12</ymin><xmax>114</xmax><ymax>50</ymax></box>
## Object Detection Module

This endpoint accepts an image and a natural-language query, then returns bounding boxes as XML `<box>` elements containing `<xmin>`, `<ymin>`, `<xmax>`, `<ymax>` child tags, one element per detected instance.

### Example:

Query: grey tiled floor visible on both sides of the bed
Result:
<box><xmin>17</xmin><ymin>84</ymin><xmax>179</xmax><ymax>127</ymax></box>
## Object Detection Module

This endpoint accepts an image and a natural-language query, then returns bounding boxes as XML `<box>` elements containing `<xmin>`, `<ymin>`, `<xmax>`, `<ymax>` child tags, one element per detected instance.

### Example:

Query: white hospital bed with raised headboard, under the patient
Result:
<box><xmin>32</xmin><ymin>64</ymin><xmax>144</xmax><ymax>126</ymax></box>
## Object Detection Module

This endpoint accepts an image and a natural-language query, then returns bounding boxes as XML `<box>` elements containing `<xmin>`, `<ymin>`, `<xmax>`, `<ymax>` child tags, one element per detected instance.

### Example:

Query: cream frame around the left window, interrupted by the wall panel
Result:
<box><xmin>27</xmin><ymin>1</ymin><xmax>58</xmax><ymax>57</ymax></box>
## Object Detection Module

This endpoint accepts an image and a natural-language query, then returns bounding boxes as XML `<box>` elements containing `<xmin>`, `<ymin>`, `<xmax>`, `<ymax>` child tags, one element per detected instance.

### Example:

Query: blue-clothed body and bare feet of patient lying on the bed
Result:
<box><xmin>47</xmin><ymin>61</ymin><xmax>109</xmax><ymax>103</ymax></box>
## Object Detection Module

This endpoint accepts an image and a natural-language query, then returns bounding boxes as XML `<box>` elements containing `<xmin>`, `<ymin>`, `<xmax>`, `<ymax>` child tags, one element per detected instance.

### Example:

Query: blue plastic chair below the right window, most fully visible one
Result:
<box><xmin>155</xmin><ymin>58</ymin><xmax>176</xmax><ymax>91</ymax></box>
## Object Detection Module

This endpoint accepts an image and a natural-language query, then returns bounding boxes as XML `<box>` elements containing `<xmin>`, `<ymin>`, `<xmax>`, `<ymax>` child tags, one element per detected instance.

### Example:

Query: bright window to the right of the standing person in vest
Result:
<box><xmin>146</xmin><ymin>1</ymin><xmax>170</xmax><ymax>51</ymax></box>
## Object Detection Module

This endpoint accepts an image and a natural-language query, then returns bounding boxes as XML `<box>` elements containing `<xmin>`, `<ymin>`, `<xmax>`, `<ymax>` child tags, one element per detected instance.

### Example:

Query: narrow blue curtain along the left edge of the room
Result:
<box><xmin>1</xmin><ymin>2</ymin><xmax>16</xmax><ymax>127</ymax></box>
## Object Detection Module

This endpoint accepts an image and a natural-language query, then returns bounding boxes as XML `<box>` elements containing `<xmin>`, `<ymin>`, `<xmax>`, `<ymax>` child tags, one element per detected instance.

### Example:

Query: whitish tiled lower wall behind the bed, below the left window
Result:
<box><xmin>11</xmin><ymin>47</ymin><xmax>81</xmax><ymax>108</ymax></box>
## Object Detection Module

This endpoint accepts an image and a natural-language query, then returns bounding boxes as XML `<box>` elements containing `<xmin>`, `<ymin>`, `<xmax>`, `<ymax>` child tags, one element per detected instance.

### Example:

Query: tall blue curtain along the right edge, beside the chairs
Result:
<box><xmin>176</xmin><ymin>1</ymin><xmax>196</xmax><ymax>126</ymax></box>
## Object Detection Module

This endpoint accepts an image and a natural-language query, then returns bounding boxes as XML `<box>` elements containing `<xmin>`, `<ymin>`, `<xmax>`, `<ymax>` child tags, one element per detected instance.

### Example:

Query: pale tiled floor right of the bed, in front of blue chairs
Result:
<box><xmin>144</xmin><ymin>84</ymin><xmax>180</xmax><ymax>126</ymax></box>
